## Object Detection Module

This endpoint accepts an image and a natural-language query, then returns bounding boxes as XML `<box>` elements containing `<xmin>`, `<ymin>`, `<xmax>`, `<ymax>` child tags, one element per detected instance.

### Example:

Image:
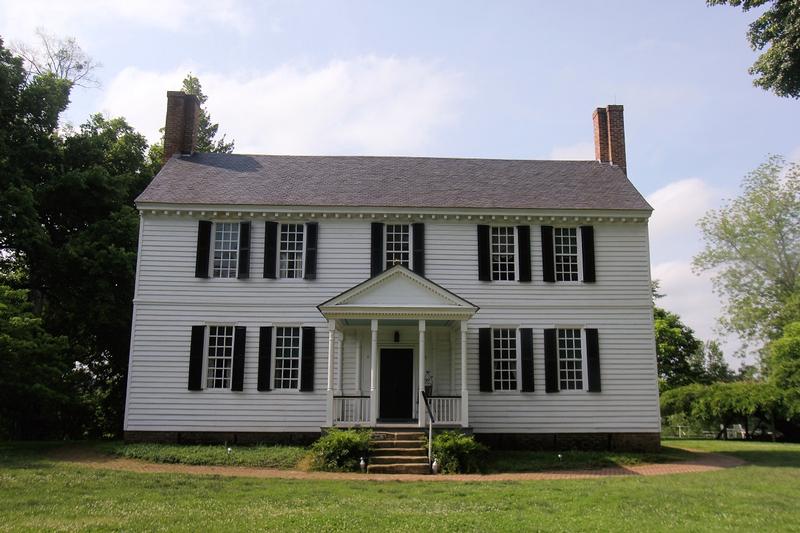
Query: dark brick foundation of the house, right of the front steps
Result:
<box><xmin>475</xmin><ymin>433</ymin><xmax>661</xmax><ymax>452</ymax></box>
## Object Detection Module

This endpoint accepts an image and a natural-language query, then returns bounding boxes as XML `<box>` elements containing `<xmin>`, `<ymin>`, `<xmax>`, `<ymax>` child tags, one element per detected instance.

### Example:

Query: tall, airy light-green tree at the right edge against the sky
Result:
<box><xmin>693</xmin><ymin>156</ymin><xmax>800</xmax><ymax>341</ymax></box>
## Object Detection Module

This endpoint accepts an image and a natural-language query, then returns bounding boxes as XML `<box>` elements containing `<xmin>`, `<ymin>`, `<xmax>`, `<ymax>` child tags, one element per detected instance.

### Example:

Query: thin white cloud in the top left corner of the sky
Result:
<box><xmin>0</xmin><ymin>0</ymin><xmax>251</xmax><ymax>40</ymax></box>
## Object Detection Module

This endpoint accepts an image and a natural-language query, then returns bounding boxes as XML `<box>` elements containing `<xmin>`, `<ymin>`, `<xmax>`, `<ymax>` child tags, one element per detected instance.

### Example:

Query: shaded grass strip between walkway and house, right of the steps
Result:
<box><xmin>485</xmin><ymin>446</ymin><xmax>691</xmax><ymax>473</ymax></box>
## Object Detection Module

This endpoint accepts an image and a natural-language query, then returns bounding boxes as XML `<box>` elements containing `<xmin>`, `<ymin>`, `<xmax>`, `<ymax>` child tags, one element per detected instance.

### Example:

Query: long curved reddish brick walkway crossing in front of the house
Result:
<box><xmin>51</xmin><ymin>447</ymin><xmax>745</xmax><ymax>481</ymax></box>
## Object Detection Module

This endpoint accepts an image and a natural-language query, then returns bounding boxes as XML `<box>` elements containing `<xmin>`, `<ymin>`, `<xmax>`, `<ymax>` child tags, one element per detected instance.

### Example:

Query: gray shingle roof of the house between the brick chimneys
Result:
<box><xmin>136</xmin><ymin>154</ymin><xmax>651</xmax><ymax>210</ymax></box>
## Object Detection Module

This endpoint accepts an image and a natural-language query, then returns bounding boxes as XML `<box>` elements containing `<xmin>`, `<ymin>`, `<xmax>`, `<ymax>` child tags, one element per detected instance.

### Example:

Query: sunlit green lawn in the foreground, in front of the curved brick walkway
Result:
<box><xmin>0</xmin><ymin>441</ymin><xmax>800</xmax><ymax>532</ymax></box>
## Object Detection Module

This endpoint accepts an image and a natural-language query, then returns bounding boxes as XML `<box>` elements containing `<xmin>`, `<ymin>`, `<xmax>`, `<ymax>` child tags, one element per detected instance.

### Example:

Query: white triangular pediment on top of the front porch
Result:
<box><xmin>319</xmin><ymin>265</ymin><xmax>478</xmax><ymax>315</ymax></box>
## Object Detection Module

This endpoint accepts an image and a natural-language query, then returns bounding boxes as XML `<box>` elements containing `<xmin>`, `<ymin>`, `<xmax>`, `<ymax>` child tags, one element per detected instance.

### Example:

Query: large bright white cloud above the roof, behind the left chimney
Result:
<box><xmin>102</xmin><ymin>56</ymin><xmax>462</xmax><ymax>154</ymax></box>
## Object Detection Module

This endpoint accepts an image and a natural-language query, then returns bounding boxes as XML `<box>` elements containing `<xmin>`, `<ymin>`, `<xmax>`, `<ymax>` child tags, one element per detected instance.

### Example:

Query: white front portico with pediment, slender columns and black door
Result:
<box><xmin>318</xmin><ymin>265</ymin><xmax>478</xmax><ymax>427</ymax></box>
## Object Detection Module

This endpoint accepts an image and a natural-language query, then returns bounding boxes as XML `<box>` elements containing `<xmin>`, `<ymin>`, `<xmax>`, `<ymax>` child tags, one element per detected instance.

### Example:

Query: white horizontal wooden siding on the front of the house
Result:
<box><xmin>126</xmin><ymin>214</ymin><xmax>659</xmax><ymax>433</ymax></box>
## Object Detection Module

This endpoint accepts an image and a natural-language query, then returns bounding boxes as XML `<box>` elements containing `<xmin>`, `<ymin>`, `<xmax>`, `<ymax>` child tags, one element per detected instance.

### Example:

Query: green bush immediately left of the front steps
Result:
<box><xmin>311</xmin><ymin>429</ymin><xmax>372</xmax><ymax>472</ymax></box>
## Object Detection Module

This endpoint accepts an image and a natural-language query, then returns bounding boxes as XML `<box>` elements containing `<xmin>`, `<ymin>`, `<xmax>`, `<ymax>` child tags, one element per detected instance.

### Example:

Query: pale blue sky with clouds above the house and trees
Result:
<box><xmin>0</xmin><ymin>0</ymin><xmax>800</xmax><ymax>364</ymax></box>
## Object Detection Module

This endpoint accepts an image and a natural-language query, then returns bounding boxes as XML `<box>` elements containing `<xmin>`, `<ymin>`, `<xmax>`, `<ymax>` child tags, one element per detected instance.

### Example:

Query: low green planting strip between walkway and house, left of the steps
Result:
<box><xmin>100</xmin><ymin>443</ymin><xmax>308</xmax><ymax>469</ymax></box>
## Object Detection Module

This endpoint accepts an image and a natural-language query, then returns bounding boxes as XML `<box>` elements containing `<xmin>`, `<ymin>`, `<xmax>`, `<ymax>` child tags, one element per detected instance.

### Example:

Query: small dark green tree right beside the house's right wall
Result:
<box><xmin>653</xmin><ymin>307</ymin><xmax>704</xmax><ymax>389</ymax></box>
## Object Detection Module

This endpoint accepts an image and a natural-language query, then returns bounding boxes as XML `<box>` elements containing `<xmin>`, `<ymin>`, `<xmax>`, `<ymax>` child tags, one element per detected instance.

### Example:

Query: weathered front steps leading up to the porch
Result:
<box><xmin>367</xmin><ymin>429</ymin><xmax>431</xmax><ymax>474</ymax></box>
